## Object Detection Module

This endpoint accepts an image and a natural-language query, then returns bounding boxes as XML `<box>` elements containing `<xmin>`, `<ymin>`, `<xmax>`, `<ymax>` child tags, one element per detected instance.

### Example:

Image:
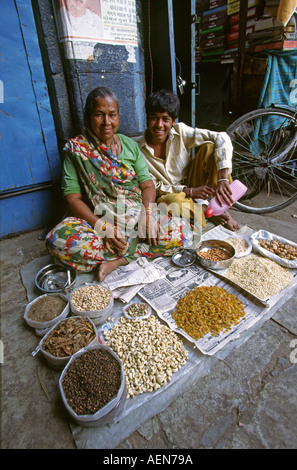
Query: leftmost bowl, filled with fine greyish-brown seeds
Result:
<box><xmin>24</xmin><ymin>293</ymin><xmax>69</xmax><ymax>336</ymax></box>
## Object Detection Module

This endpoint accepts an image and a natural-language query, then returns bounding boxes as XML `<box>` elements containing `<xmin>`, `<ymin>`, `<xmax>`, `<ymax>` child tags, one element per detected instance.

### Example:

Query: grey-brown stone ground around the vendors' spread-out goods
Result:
<box><xmin>0</xmin><ymin>200</ymin><xmax>297</xmax><ymax>449</ymax></box>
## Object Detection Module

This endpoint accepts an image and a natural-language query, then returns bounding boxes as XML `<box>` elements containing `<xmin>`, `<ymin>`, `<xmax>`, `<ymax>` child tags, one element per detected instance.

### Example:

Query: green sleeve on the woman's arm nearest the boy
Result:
<box><xmin>118</xmin><ymin>134</ymin><xmax>152</xmax><ymax>183</ymax></box>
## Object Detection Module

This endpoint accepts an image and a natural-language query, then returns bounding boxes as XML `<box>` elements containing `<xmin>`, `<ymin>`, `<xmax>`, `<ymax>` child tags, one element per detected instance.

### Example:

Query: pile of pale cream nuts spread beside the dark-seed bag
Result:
<box><xmin>104</xmin><ymin>315</ymin><xmax>188</xmax><ymax>397</ymax></box>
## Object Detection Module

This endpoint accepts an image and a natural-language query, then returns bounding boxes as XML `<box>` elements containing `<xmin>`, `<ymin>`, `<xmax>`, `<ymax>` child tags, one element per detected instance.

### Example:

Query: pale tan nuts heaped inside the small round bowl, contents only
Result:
<box><xmin>71</xmin><ymin>284</ymin><xmax>111</xmax><ymax>312</ymax></box>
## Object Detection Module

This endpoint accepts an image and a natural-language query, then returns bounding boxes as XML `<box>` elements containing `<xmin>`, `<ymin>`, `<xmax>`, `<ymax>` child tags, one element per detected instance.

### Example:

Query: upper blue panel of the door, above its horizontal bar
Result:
<box><xmin>0</xmin><ymin>1</ymin><xmax>60</xmax><ymax>191</ymax></box>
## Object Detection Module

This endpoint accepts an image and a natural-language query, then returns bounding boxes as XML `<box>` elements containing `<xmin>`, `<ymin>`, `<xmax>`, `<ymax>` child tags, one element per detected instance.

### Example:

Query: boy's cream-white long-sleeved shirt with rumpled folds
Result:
<box><xmin>136</xmin><ymin>122</ymin><xmax>233</xmax><ymax>193</ymax></box>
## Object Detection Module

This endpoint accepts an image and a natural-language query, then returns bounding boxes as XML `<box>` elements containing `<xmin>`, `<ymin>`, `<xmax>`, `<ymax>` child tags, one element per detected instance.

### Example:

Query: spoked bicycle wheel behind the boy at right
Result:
<box><xmin>226</xmin><ymin>107</ymin><xmax>297</xmax><ymax>214</ymax></box>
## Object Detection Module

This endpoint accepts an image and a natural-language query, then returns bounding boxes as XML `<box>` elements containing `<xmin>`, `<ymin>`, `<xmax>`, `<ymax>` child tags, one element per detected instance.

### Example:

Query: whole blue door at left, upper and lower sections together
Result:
<box><xmin>0</xmin><ymin>0</ymin><xmax>61</xmax><ymax>237</ymax></box>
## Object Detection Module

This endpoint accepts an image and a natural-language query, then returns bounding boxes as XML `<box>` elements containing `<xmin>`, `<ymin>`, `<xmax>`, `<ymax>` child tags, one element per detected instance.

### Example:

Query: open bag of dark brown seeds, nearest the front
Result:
<box><xmin>59</xmin><ymin>344</ymin><xmax>127</xmax><ymax>427</ymax></box>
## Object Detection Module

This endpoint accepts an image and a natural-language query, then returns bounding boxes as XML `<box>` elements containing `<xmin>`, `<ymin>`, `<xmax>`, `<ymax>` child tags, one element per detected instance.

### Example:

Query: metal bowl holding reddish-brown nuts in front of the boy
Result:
<box><xmin>196</xmin><ymin>240</ymin><xmax>235</xmax><ymax>270</ymax></box>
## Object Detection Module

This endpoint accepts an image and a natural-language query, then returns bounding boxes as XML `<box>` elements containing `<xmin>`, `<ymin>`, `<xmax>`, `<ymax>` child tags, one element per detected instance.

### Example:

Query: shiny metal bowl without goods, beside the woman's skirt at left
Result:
<box><xmin>35</xmin><ymin>264</ymin><xmax>76</xmax><ymax>294</ymax></box>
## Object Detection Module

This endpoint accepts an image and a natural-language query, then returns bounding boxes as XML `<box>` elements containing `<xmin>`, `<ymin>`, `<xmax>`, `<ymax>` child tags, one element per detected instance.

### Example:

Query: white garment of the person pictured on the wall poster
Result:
<box><xmin>57</xmin><ymin>6</ymin><xmax>103</xmax><ymax>41</ymax></box>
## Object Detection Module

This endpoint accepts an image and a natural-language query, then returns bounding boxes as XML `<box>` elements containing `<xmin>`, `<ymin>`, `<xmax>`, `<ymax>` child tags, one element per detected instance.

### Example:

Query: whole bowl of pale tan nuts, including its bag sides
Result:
<box><xmin>70</xmin><ymin>284</ymin><xmax>114</xmax><ymax>325</ymax></box>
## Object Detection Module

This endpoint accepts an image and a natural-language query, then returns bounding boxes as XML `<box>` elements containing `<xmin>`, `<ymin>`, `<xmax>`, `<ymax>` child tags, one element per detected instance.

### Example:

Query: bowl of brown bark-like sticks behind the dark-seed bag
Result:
<box><xmin>39</xmin><ymin>317</ymin><xmax>99</xmax><ymax>370</ymax></box>
